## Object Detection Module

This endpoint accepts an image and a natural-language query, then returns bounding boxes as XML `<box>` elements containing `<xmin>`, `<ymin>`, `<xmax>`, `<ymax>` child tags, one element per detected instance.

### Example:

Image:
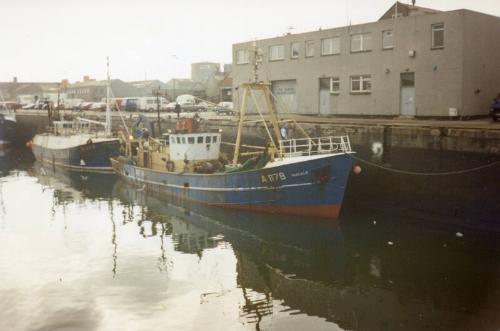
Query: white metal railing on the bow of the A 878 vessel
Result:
<box><xmin>279</xmin><ymin>136</ymin><xmax>352</xmax><ymax>157</ymax></box>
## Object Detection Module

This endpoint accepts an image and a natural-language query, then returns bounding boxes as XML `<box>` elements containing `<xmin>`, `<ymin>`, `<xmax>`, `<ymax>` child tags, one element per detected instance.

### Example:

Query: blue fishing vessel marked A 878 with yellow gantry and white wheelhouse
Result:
<box><xmin>112</xmin><ymin>45</ymin><xmax>353</xmax><ymax>219</ymax></box>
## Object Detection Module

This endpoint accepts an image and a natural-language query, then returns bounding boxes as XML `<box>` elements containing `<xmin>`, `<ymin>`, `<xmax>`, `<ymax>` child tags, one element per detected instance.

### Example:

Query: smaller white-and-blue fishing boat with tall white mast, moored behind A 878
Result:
<box><xmin>30</xmin><ymin>62</ymin><xmax>121</xmax><ymax>172</ymax></box>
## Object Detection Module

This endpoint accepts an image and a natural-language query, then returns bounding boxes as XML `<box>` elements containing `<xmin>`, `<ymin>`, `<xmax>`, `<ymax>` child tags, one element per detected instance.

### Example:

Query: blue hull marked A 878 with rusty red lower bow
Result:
<box><xmin>112</xmin><ymin>154</ymin><xmax>352</xmax><ymax>218</ymax></box>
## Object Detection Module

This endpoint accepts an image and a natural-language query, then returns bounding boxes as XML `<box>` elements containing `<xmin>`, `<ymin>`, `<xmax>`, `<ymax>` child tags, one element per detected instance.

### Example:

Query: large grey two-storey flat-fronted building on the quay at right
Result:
<box><xmin>232</xmin><ymin>2</ymin><xmax>500</xmax><ymax>117</ymax></box>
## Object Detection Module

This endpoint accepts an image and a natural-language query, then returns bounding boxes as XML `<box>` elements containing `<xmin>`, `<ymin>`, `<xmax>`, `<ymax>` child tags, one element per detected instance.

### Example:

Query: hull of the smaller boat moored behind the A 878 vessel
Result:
<box><xmin>32</xmin><ymin>140</ymin><xmax>120</xmax><ymax>172</ymax></box>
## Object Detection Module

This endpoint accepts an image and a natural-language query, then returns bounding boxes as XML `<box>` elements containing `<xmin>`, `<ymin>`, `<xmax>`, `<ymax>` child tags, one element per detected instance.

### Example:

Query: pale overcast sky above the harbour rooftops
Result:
<box><xmin>0</xmin><ymin>0</ymin><xmax>500</xmax><ymax>82</ymax></box>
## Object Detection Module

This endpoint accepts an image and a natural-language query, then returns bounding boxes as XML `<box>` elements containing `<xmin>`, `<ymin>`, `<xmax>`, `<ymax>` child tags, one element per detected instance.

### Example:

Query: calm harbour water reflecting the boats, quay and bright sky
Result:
<box><xmin>0</xmin><ymin>150</ymin><xmax>500</xmax><ymax>330</ymax></box>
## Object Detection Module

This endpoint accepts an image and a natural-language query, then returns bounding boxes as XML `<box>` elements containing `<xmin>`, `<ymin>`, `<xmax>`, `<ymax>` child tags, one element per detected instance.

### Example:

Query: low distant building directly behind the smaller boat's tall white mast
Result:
<box><xmin>64</xmin><ymin>79</ymin><xmax>142</xmax><ymax>101</ymax></box>
